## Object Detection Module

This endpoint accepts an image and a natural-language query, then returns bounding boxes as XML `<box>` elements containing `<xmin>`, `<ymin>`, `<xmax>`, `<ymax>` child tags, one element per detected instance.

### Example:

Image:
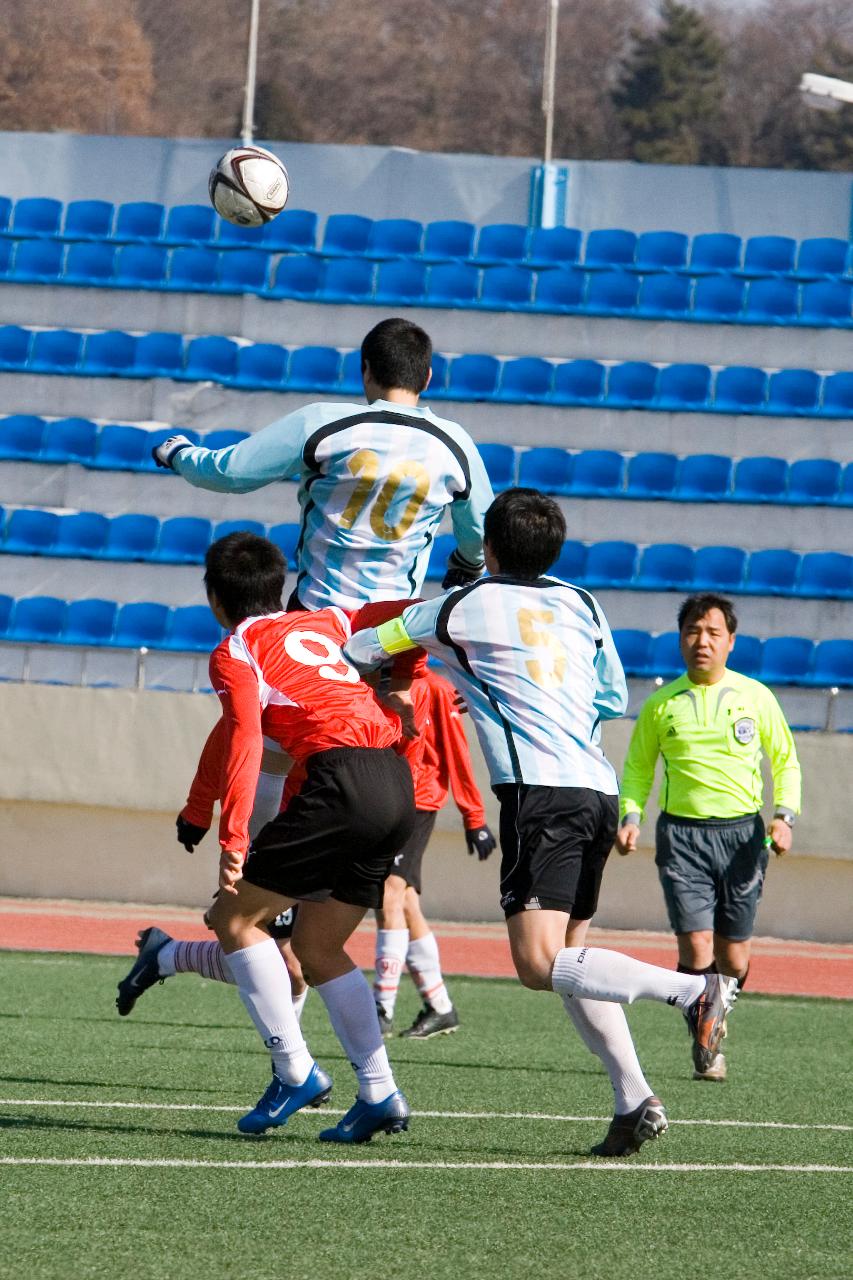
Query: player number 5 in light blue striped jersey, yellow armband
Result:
<box><xmin>346</xmin><ymin>489</ymin><xmax>736</xmax><ymax>1156</ymax></box>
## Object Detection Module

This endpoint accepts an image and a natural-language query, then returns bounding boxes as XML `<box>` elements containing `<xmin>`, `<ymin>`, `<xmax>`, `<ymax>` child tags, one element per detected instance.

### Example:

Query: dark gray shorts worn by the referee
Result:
<box><xmin>654</xmin><ymin>813</ymin><xmax>770</xmax><ymax>942</ymax></box>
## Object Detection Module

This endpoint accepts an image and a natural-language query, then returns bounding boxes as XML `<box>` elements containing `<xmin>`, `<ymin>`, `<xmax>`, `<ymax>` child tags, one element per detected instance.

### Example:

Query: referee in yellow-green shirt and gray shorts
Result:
<box><xmin>616</xmin><ymin>591</ymin><xmax>800</xmax><ymax>1080</ymax></box>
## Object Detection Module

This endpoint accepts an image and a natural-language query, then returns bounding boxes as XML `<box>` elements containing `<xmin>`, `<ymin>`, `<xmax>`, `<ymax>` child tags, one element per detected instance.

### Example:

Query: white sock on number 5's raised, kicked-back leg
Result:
<box><xmin>551</xmin><ymin>947</ymin><xmax>704</xmax><ymax>1009</ymax></box>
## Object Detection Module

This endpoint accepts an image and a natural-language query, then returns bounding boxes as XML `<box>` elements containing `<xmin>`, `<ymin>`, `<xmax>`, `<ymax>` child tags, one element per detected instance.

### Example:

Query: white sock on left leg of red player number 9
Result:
<box><xmin>228</xmin><ymin>938</ymin><xmax>314</xmax><ymax>1084</ymax></box>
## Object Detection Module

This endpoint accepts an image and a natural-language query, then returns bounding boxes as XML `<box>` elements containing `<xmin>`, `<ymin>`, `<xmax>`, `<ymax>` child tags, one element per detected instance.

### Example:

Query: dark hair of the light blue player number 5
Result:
<box><xmin>483</xmin><ymin>489</ymin><xmax>566</xmax><ymax>580</ymax></box>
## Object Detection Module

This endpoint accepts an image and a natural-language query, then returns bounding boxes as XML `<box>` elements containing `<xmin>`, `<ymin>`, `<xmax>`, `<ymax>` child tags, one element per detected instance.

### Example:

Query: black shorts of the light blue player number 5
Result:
<box><xmin>494</xmin><ymin>782</ymin><xmax>619</xmax><ymax>920</ymax></box>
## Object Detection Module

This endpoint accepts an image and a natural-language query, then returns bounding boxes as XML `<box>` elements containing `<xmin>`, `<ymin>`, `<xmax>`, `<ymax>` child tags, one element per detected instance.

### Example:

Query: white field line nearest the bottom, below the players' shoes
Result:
<box><xmin>0</xmin><ymin>1156</ymin><xmax>853</xmax><ymax>1174</ymax></box>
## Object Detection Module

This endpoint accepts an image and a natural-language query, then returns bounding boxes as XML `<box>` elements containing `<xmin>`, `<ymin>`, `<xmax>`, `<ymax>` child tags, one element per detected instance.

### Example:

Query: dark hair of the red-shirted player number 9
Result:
<box><xmin>205</xmin><ymin>532</ymin><xmax>287</xmax><ymax>626</ymax></box>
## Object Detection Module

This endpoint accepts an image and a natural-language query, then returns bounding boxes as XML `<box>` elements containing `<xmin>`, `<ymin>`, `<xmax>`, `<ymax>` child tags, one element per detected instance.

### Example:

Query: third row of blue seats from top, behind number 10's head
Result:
<box><xmin>0</xmin><ymin>325</ymin><xmax>853</xmax><ymax>417</ymax></box>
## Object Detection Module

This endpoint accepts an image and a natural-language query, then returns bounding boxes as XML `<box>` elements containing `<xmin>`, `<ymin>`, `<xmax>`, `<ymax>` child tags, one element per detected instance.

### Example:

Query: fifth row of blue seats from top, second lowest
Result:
<box><xmin>0</xmin><ymin>507</ymin><xmax>853</xmax><ymax>600</ymax></box>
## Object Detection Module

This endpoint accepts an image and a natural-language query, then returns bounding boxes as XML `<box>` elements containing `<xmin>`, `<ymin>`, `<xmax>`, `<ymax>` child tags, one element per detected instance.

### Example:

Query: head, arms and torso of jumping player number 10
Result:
<box><xmin>154</xmin><ymin>319</ymin><xmax>493</xmax><ymax>609</ymax></box>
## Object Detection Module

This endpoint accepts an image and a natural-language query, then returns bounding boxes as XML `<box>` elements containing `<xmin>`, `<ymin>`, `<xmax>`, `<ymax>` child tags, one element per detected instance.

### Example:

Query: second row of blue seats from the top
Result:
<box><xmin>0</xmin><ymin>239</ymin><xmax>853</xmax><ymax>328</ymax></box>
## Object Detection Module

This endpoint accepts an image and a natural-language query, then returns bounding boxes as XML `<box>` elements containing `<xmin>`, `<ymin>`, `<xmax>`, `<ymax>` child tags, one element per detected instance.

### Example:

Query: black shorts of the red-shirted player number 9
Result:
<box><xmin>243</xmin><ymin>746</ymin><xmax>415</xmax><ymax>908</ymax></box>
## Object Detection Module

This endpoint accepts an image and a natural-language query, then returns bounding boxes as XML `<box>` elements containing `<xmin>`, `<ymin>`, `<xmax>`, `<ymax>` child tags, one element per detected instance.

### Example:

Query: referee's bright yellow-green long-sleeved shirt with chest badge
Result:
<box><xmin>620</xmin><ymin>669</ymin><xmax>800</xmax><ymax>819</ymax></box>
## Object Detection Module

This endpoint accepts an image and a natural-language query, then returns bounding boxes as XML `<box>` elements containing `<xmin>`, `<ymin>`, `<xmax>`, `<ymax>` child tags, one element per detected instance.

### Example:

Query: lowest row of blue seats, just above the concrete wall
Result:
<box><xmin>0</xmin><ymin>595</ymin><xmax>853</xmax><ymax>687</ymax></box>
